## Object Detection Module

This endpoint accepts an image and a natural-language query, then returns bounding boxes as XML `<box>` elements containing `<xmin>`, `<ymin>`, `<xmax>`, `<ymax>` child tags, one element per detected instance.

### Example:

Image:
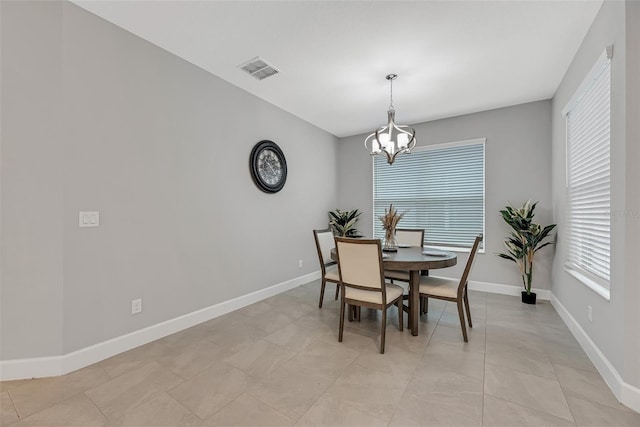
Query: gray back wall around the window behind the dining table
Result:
<box><xmin>338</xmin><ymin>100</ymin><xmax>553</xmax><ymax>289</ymax></box>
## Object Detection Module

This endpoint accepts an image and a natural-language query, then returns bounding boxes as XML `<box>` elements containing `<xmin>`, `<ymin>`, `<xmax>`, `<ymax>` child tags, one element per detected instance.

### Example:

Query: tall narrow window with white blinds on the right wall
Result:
<box><xmin>563</xmin><ymin>48</ymin><xmax>612</xmax><ymax>299</ymax></box>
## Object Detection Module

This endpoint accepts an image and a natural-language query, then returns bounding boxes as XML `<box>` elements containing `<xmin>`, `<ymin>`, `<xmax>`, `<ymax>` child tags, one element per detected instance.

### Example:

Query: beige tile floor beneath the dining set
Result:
<box><xmin>0</xmin><ymin>282</ymin><xmax>640</xmax><ymax>427</ymax></box>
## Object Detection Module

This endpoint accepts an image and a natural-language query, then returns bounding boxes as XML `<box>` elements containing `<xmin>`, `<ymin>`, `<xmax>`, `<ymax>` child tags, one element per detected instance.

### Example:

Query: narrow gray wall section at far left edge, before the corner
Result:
<box><xmin>0</xmin><ymin>2</ymin><xmax>64</xmax><ymax>359</ymax></box>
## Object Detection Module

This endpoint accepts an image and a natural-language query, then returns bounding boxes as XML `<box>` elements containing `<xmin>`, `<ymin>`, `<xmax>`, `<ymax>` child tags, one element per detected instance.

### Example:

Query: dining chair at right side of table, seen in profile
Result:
<box><xmin>419</xmin><ymin>234</ymin><xmax>482</xmax><ymax>342</ymax></box>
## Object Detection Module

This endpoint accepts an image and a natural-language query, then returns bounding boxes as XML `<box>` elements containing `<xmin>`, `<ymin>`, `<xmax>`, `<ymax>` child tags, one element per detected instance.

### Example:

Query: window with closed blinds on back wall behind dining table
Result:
<box><xmin>373</xmin><ymin>139</ymin><xmax>485</xmax><ymax>250</ymax></box>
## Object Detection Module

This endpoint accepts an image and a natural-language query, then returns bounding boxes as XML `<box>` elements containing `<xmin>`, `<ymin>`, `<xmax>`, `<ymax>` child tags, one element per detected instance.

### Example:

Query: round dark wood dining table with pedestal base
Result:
<box><xmin>331</xmin><ymin>246</ymin><xmax>458</xmax><ymax>336</ymax></box>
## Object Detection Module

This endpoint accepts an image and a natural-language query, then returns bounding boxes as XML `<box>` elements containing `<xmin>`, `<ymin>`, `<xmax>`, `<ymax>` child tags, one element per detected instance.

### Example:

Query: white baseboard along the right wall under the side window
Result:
<box><xmin>551</xmin><ymin>294</ymin><xmax>640</xmax><ymax>412</ymax></box>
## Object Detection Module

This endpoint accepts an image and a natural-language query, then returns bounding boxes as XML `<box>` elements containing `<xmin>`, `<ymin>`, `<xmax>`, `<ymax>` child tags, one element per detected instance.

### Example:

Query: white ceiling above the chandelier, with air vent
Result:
<box><xmin>73</xmin><ymin>0</ymin><xmax>602</xmax><ymax>137</ymax></box>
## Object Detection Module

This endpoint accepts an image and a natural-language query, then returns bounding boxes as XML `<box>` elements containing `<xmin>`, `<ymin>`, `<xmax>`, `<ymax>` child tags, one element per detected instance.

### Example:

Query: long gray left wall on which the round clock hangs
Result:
<box><xmin>0</xmin><ymin>1</ymin><xmax>337</xmax><ymax>360</ymax></box>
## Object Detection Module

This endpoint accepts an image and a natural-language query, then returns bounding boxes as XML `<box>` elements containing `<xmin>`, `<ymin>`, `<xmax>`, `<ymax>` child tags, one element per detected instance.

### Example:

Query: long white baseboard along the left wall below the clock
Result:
<box><xmin>0</xmin><ymin>271</ymin><xmax>320</xmax><ymax>381</ymax></box>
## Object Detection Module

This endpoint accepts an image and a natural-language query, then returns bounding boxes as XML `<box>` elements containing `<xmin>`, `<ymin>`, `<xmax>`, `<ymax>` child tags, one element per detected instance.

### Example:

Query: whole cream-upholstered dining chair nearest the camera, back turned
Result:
<box><xmin>335</xmin><ymin>237</ymin><xmax>404</xmax><ymax>354</ymax></box>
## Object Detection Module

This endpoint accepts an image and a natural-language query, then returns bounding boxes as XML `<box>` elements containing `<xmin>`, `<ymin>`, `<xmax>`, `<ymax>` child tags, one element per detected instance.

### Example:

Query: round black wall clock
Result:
<box><xmin>249</xmin><ymin>140</ymin><xmax>287</xmax><ymax>193</ymax></box>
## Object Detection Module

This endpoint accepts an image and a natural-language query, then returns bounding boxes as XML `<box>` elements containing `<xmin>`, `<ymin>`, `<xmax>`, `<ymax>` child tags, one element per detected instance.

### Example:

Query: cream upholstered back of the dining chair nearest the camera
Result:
<box><xmin>336</xmin><ymin>237</ymin><xmax>385</xmax><ymax>294</ymax></box>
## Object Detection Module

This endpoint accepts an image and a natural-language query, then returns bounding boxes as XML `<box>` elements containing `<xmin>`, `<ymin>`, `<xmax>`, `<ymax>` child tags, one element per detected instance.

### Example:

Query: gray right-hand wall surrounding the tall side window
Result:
<box><xmin>552</xmin><ymin>1</ymin><xmax>640</xmax><ymax>387</ymax></box>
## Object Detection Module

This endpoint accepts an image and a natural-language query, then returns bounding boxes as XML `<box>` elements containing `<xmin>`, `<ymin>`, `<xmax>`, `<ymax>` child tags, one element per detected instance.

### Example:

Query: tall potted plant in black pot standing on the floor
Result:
<box><xmin>497</xmin><ymin>200</ymin><xmax>556</xmax><ymax>304</ymax></box>
